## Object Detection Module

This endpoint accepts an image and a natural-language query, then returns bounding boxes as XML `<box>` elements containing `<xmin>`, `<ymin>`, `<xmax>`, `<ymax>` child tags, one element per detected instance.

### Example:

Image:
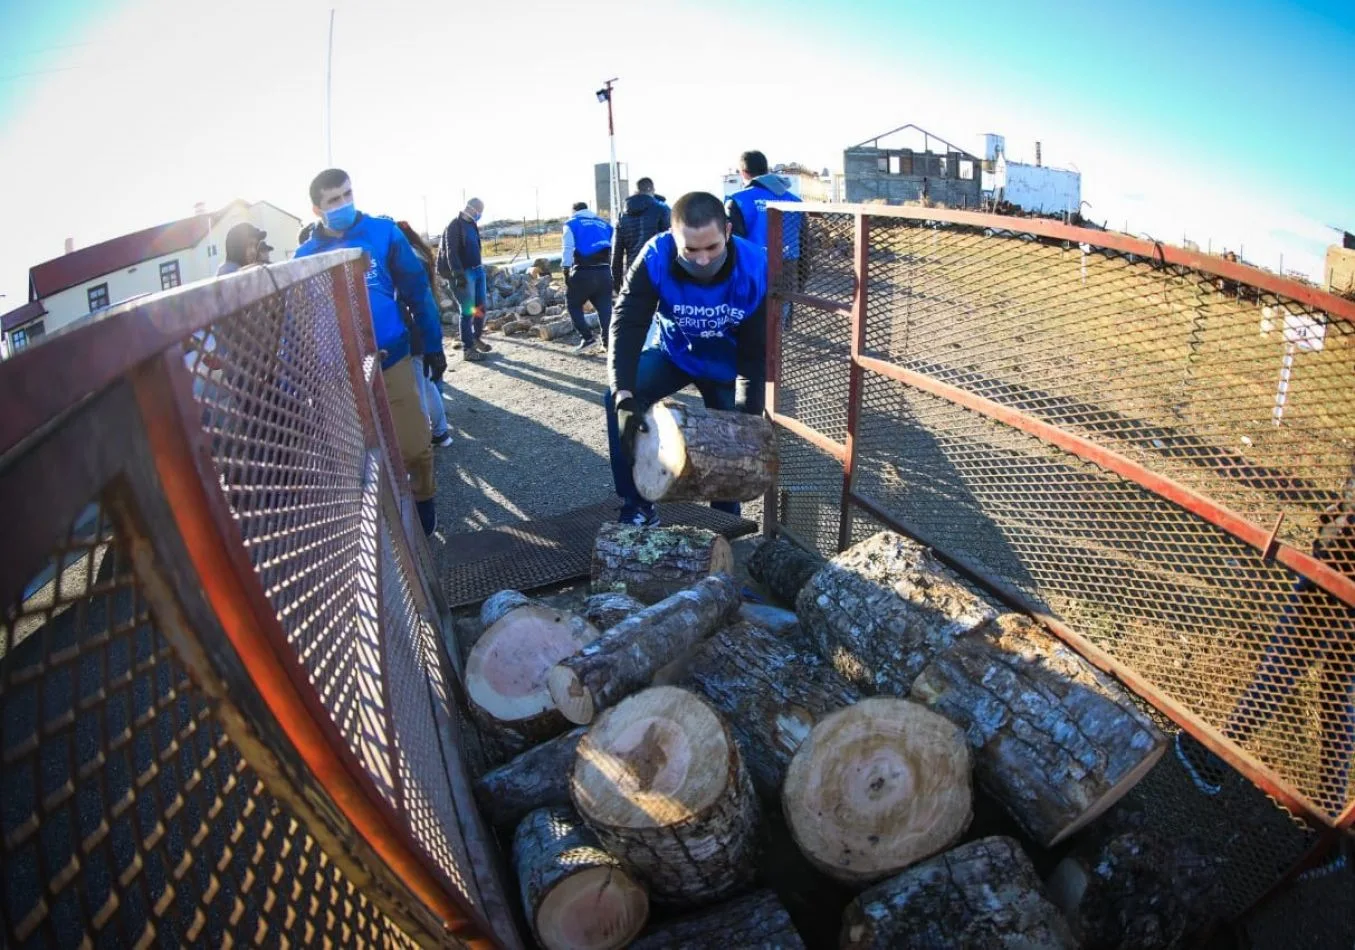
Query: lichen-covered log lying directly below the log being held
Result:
<box><xmin>592</xmin><ymin>523</ymin><xmax>734</xmax><ymax>603</ymax></box>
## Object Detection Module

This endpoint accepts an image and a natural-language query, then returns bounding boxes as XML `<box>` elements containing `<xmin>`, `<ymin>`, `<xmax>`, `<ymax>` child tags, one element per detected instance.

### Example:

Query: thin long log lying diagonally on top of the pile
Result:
<box><xmin>547</xmin><ymin>575</ymin><xmax>738</xmax><ymax>725</ymax></box>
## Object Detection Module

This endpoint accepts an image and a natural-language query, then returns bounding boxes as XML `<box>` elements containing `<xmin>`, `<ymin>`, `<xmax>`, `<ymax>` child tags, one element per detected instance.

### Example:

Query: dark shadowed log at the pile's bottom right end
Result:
<box><xmin>1046</xmin><ymin>809</ymin><xmax>1224</xmax><ymax>950</ymax></box>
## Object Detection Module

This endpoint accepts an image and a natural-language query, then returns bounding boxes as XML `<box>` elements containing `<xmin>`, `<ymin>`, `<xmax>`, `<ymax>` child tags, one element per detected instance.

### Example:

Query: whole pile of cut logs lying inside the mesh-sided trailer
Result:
<box><xmin>466</xmin><ymin>471</ymin><xmax>1211</xmax><ymax>950</ymax></box>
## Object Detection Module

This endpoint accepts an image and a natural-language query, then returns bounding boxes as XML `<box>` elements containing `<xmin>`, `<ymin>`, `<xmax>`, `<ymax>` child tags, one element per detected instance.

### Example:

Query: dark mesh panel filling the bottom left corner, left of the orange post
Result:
<box><xmin>0</xmin><ymin>504</ymin><xmax>415</xmax><ymax>949</ymax></box>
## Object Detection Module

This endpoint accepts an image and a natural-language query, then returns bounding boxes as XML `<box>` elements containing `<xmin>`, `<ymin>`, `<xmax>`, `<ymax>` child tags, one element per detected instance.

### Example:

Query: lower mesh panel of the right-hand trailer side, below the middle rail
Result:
<box><xmin>855</xmin><ymin>375</ymin><xmax>1355</xmax><ymax>817</ymax></box>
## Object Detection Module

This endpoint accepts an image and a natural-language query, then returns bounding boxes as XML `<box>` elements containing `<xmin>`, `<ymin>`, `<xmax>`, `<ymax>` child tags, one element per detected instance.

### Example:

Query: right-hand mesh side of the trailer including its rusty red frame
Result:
<box><xmin>770</xmin><ymin>206</ymin><xmax>1355</xmax><ymax>913</ymax></box>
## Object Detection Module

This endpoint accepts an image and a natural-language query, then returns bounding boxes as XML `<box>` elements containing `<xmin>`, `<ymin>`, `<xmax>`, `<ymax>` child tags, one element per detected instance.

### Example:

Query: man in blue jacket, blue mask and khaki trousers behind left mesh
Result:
<box><xmin>297</xmin><ymin>168</ymin><xmax>447</xmax><ymax>534</ymax></box>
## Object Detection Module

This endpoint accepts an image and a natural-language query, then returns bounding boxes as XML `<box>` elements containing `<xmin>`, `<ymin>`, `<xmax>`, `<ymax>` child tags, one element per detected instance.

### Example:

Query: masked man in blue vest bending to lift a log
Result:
<box><xmin>604</xmin><ymin>191</ymin><xmax>767</xmax><ymax>526</ymax></box>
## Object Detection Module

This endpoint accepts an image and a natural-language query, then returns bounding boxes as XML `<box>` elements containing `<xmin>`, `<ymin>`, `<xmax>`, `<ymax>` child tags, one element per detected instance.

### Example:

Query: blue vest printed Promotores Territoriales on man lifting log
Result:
<box><xmin>644</xmin><ymin>232</ymin><xmax>767</xmax><ymax>382</ymax></box>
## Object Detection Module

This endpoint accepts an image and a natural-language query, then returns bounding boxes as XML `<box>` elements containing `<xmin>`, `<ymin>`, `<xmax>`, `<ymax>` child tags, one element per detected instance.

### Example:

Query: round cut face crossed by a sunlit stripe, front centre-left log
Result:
<box><xmin>573</xmin><ymin>686</ymin><xmax>734</xmax><ymax>828</ymax></box>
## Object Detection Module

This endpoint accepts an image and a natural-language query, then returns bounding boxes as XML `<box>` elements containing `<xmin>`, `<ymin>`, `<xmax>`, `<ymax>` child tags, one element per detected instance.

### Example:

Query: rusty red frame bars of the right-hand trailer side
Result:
<box><xmin>763</xmin><ymin>202</ymin><xmax>1355</xmax><ymax>834</ymax></box>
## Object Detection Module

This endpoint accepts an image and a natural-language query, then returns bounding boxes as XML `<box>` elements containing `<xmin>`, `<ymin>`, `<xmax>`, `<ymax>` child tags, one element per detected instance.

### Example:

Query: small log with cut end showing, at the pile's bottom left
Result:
<box><xmin>512</xmin><ymin>808</ymin><xmax>649</xmax><ymax>950</ymax></box>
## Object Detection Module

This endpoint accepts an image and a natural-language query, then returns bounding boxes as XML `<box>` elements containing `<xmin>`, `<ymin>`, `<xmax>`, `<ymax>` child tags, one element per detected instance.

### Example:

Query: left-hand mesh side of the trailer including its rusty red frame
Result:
<box><xmin>0</xmin><ymin>252</ymin><xmax>519</xmax><ymax>947</ymax></box>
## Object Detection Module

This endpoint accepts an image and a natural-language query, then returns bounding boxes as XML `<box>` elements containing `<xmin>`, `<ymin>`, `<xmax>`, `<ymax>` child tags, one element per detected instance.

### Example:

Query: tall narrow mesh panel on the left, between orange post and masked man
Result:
<box><xmin>184</xmin><ymin>274</ymin><xmax>396</xmax><ymax>804</ymax></box>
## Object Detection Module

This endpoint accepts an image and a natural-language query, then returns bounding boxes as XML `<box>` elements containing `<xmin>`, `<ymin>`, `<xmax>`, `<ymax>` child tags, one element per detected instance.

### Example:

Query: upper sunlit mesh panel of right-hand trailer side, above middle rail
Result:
<box><xmin>867</xmin><ymin>217</ymin><xmax>1355</xmax><ymax>552</ymax></box>
